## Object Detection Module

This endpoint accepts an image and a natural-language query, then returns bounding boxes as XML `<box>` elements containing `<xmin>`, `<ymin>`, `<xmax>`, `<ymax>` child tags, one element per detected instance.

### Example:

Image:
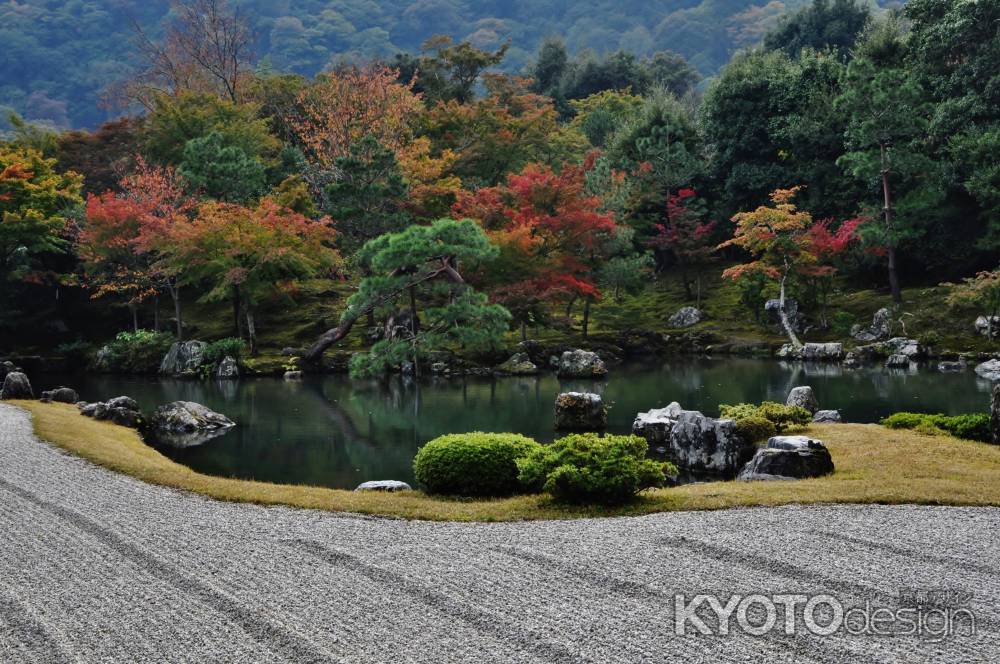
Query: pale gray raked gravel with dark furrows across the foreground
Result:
<box><xmin>0</xmin><ymin>404</ymin><xmax>1000</xmax><ymax>664</ymax></box>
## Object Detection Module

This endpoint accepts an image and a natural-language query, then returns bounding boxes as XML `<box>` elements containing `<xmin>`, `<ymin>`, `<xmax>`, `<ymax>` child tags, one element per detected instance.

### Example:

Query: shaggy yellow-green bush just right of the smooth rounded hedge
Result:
<box><xmin>517</xmin><ymin>433</ymin><xmax>677</xmax><ymax>505</ymax></box>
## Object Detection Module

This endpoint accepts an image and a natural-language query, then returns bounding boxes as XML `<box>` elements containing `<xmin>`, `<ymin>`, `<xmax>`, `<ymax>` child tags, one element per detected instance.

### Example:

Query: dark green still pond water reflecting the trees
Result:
<box><xmin>33</xmin><ymin>358</ymin><xmax>990</xmax><ymax>488</ymax></box>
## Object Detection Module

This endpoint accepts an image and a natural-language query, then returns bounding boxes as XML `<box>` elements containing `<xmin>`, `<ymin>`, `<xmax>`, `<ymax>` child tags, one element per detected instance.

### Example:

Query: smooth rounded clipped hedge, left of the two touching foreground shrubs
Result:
<box><xmin>413</xmin><ymin>431</ymin><xmax>540</xmax><ymax>496</ymax></box>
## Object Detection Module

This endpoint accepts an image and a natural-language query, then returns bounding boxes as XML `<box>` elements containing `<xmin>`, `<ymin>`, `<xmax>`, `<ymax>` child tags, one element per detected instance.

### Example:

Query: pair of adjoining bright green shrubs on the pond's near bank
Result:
<box><xmin>413</xmin><ymin>432</ymin><xmax>677</xmax><ymax>504</ymax></box>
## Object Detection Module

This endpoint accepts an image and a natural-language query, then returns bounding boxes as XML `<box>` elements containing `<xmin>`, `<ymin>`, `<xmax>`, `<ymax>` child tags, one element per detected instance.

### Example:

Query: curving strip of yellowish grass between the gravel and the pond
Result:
<box><xmin>14</xmin><ymin>401</ymin><xmax>1000</xmax><ymax>521</ymax></box>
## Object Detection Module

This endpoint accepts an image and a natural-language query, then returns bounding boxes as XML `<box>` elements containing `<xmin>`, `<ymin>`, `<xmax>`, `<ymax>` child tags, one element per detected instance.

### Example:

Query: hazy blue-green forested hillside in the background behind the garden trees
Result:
<box><xmin>0</xmin><ymin>0</ymin><xmax>886</xmax><ymax>128</ymax></box>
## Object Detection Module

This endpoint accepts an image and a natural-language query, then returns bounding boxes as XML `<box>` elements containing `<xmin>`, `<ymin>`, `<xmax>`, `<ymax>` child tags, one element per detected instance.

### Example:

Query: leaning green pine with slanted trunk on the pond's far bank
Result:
<box><xmin>305</xmin><ymin>219</ymin><xmax>510</xmax><ymax>375</ymax></box>
